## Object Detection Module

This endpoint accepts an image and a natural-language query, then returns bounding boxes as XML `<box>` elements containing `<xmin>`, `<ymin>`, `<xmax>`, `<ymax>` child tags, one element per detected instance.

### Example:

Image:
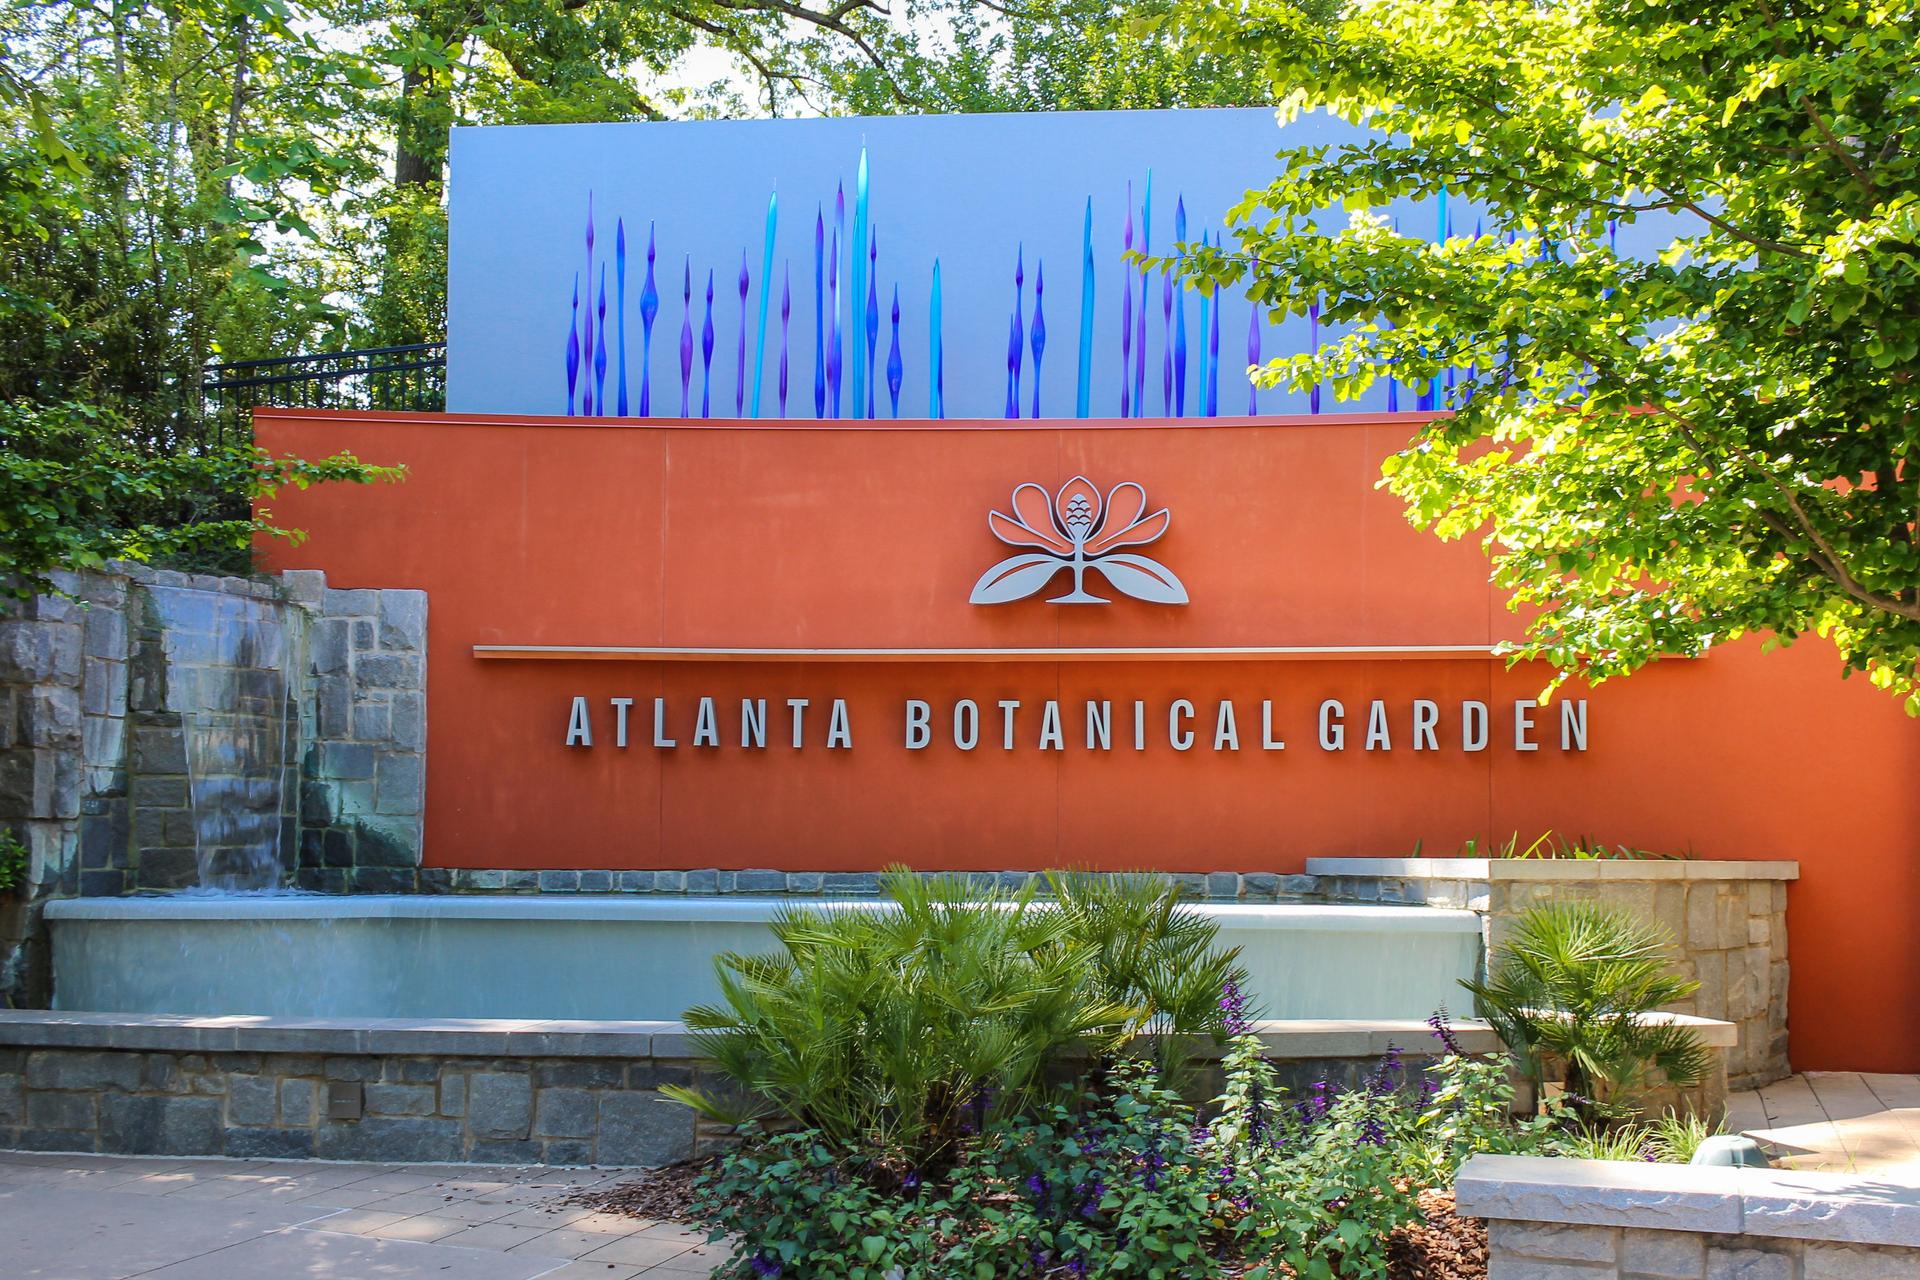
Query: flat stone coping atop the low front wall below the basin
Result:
<box><xmin>0</xmin><ymin>1009</ymin><xmax>1740</xmax><ymax>1059</ymax></box>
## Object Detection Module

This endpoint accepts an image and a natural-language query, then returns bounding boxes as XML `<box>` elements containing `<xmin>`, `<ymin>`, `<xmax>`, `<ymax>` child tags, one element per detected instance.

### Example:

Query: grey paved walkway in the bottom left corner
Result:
<box><xmin>0</xmin><ymin>1151</ymin><xmax>722</xmax><ymax>1280</ymax></box>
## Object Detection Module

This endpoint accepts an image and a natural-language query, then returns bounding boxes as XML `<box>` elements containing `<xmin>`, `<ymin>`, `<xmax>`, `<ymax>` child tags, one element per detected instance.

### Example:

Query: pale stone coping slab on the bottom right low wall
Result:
<box><xmin>1453</xmin><ymin>1155</ymin><xmax>1920</xmax><ymax>1243</ymax></box>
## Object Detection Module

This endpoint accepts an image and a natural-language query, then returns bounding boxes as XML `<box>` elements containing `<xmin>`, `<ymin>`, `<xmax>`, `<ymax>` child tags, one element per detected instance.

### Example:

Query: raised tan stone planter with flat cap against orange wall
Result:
<box><xmin>1308</xmin><ymin>858</ymin><xmax>1799</xmax><ymax>1088</ymax></box>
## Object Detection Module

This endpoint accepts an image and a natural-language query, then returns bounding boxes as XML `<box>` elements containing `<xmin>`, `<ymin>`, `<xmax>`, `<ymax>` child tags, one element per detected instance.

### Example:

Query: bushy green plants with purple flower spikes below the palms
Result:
<box><xmin>695</xmin><ymin>1034</ymin><xmax>1549</xmax><ymax>1280</ymax></box>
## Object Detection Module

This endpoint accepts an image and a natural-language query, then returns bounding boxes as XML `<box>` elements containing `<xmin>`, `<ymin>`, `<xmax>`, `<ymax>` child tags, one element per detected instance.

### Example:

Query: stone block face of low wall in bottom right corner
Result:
<box><xmin>1488</xmin><ymin>1221</ymin><xmax>1920</xmax><ymax>1280</ymax></box>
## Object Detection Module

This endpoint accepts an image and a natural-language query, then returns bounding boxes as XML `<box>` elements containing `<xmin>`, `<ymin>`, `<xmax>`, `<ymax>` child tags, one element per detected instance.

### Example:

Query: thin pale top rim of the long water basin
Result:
<box><xmin>46</xmin><ymin>894</ymin><xmax>1480</xmax><ymax>933</ymax></box>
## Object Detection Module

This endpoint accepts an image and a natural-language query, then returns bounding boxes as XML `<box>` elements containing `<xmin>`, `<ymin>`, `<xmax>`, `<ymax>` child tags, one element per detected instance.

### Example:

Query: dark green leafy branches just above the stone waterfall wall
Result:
<box><xmin>0</xmin><ymin>401</ymin><xmax>403</xmax><ymax>599</ymax></box>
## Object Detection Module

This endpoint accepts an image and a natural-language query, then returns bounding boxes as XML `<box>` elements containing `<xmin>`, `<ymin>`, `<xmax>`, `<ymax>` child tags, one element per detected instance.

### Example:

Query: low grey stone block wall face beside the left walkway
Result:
<box><xmin>0</xmin><ymin>1048</ymin><xmax>707</xmax><ymax>1165</ymax></box>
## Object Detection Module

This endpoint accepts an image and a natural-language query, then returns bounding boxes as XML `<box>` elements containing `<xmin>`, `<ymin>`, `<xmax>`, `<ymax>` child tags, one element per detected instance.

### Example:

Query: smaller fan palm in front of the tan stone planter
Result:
<box><xmin>1461</xmin><ymin>902</ymin><xmax>1713</xmax><ymax>1125</ymax></box>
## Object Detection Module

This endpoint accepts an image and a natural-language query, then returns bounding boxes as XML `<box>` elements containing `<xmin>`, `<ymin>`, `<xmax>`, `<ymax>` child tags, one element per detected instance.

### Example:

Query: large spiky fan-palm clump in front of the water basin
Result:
<box><xmin>676</xmin><ymin>867</ymin><xmax>1238</xmax><ymax>1171</ymax></box>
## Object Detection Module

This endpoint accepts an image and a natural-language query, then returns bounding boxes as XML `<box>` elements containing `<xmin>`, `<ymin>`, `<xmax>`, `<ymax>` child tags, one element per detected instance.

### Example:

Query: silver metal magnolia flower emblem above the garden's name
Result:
<box><xmin>972</xmin><ymin>476</ymin><xmax>1187</xmax><ymax>604</ymax></box>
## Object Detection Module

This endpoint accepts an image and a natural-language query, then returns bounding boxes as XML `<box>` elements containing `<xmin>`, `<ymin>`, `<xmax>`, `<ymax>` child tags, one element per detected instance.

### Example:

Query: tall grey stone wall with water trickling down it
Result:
<box><xmin>0</xmin><ymin>564</ymin><xmax>426</xmax><ymax>1007</ymax></box>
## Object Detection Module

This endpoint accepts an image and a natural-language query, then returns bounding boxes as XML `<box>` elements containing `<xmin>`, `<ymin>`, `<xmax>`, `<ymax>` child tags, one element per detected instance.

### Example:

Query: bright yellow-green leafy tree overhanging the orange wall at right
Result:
<box><xmin>1187</xmin><ymin>0</ymin><xmax>1920</xmax><ymax>714</ymax></box>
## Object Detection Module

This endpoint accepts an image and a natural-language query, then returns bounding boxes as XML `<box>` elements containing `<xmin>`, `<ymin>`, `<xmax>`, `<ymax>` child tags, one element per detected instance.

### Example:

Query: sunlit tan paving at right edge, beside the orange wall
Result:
<box><xmin>1726</xmin><ymin>1071</ymin><xmax>1920</xmax><ymax>1182</ymax></box>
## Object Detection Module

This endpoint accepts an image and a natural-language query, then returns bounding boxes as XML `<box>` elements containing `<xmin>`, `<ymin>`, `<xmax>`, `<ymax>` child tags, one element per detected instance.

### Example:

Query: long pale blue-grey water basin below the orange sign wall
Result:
<box><xmin>46</xmin><ymin>894</ymin><xmax>1480</xmax><ymax>1019</ymax></box>
